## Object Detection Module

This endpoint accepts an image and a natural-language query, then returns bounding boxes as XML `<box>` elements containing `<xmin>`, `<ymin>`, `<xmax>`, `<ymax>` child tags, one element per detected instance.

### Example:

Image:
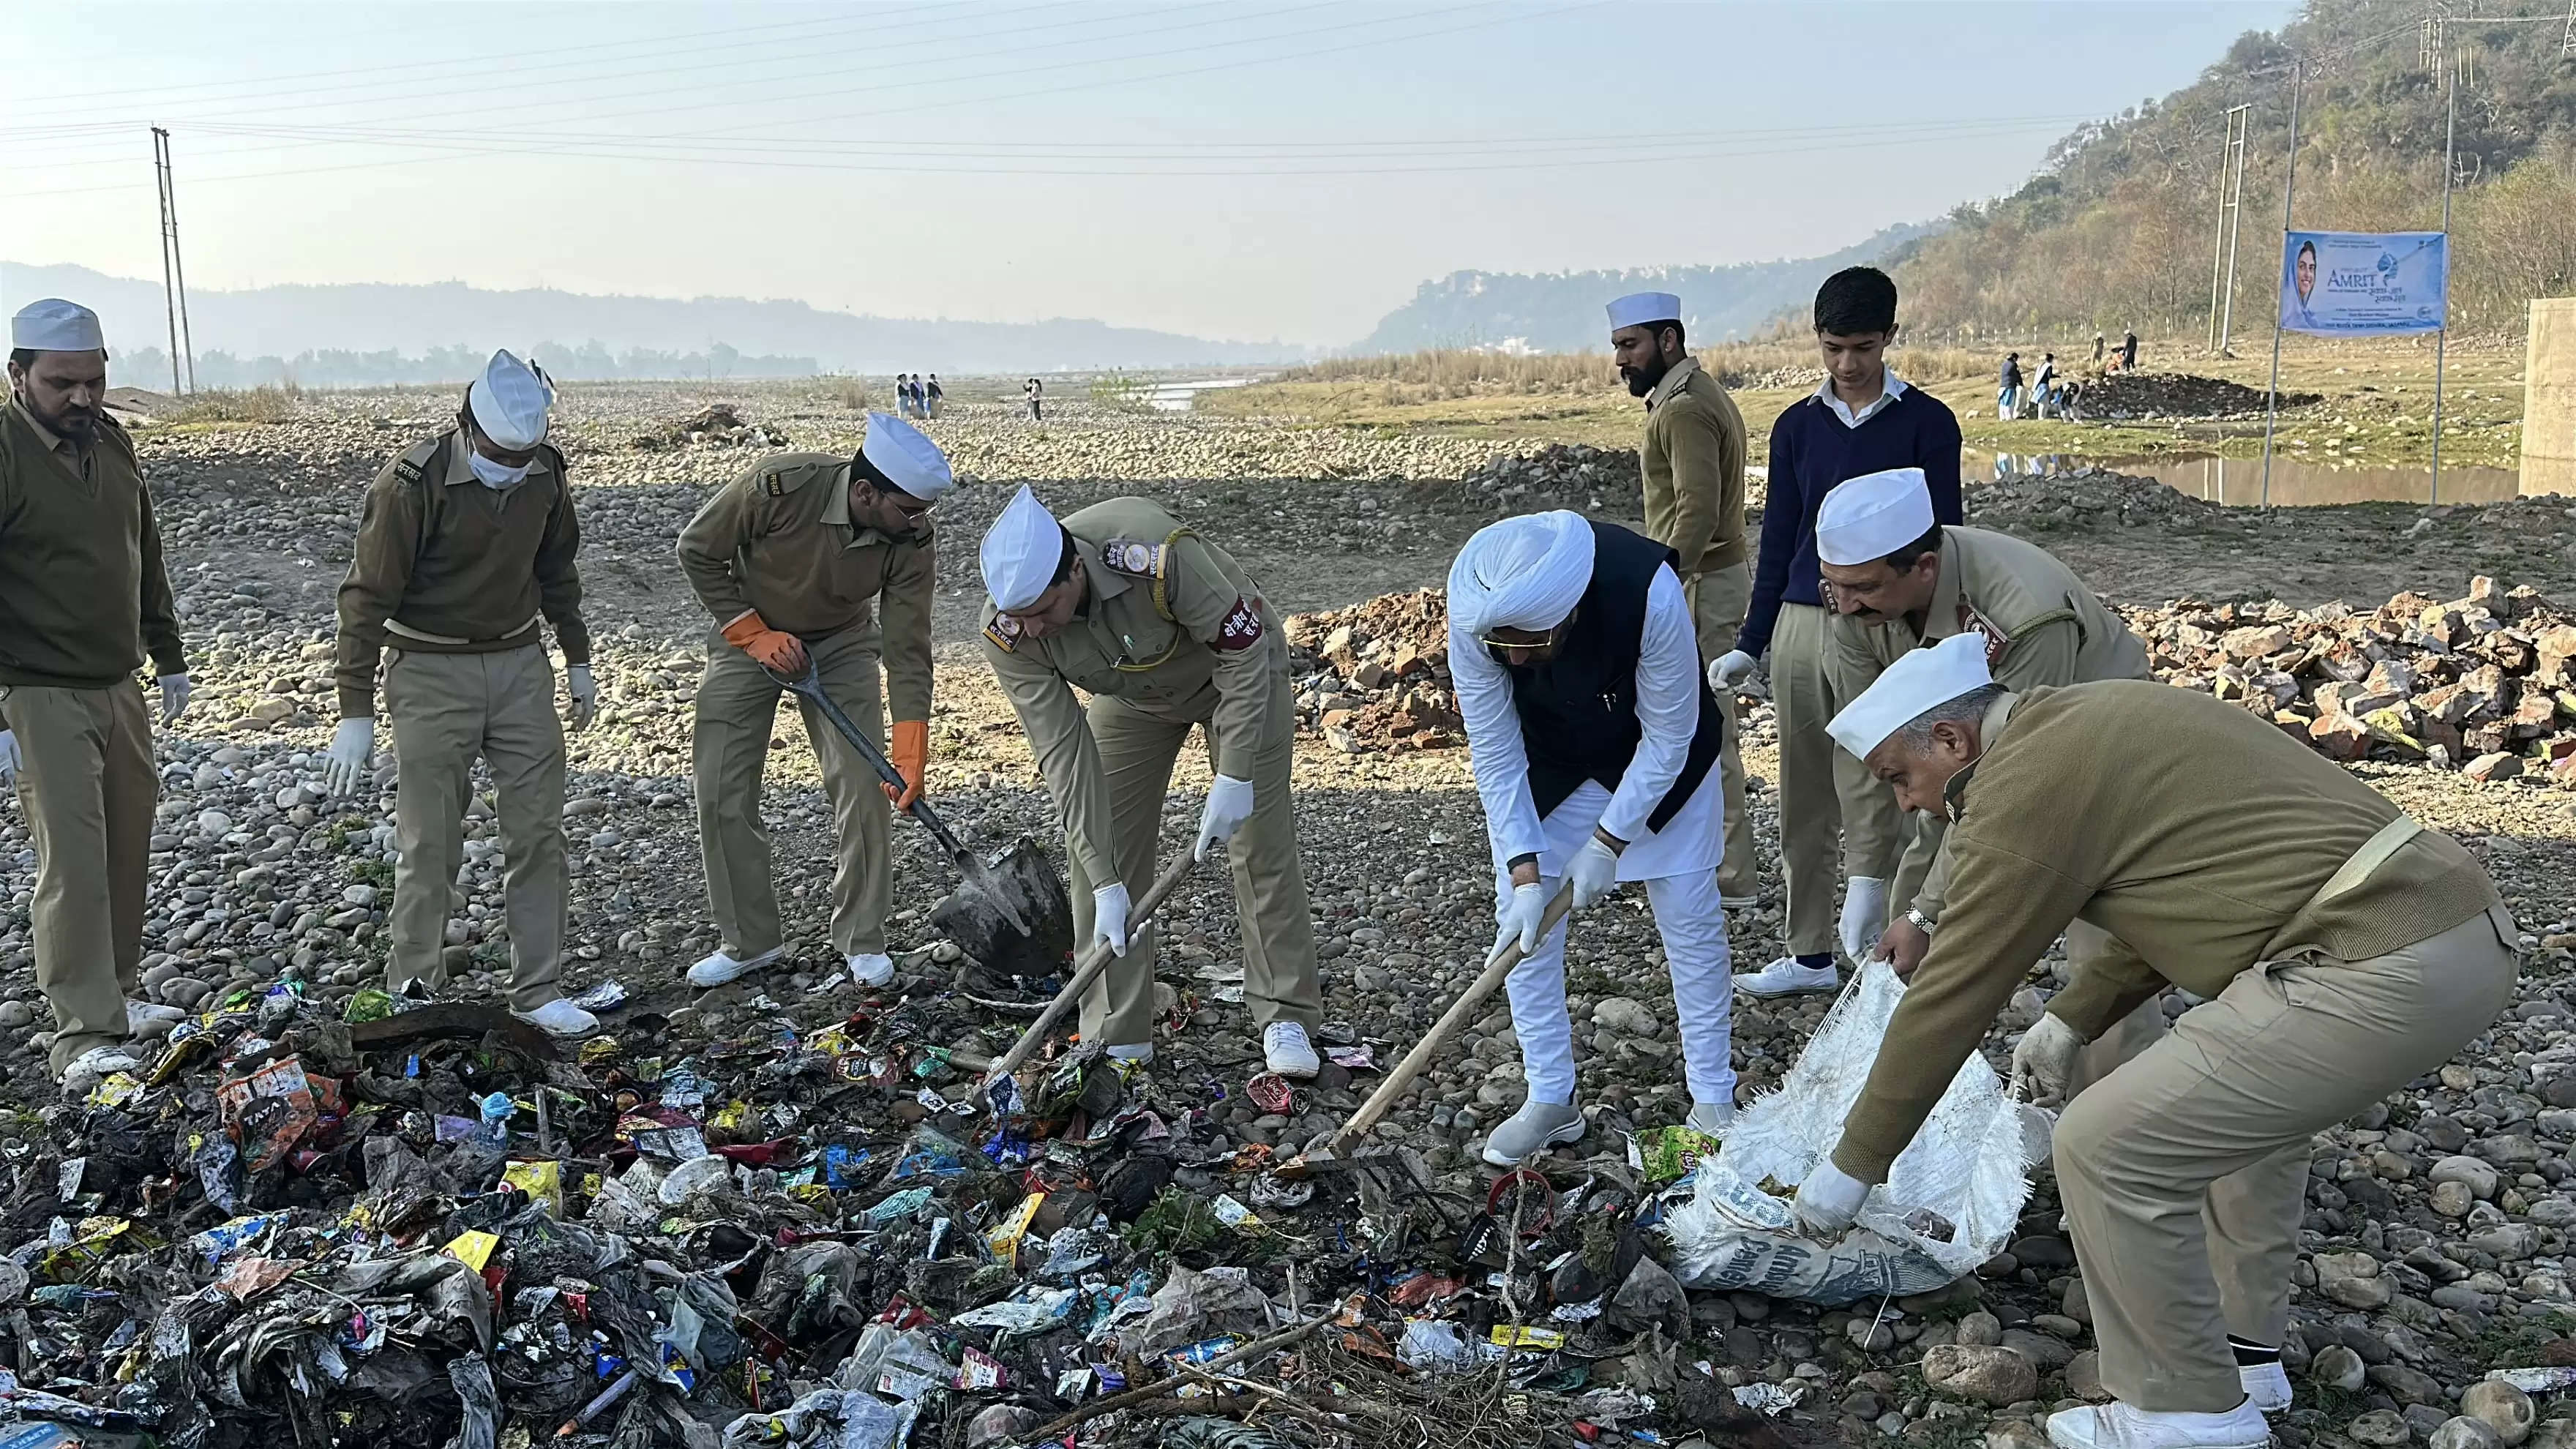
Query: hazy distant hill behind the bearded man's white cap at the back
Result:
<box><xmin>1349</xmin><ymin>225</ymin><xmax>1932</xmax><ymax>353</ymax></box>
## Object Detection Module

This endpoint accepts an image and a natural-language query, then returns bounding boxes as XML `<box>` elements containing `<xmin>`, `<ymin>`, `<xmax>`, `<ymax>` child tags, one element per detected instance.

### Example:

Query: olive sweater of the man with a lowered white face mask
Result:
<box><xmin>337</xmin><ymin>428</ymin><xmax>590</xmax><ymax>719</ymax></box>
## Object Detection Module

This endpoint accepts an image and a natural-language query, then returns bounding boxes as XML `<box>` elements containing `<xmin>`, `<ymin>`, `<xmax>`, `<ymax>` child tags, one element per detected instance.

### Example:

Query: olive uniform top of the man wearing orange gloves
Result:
<box><xmin>680</xmin><ymin>454</ymin><xmax>937</xmax><ymax>719</ymax></box>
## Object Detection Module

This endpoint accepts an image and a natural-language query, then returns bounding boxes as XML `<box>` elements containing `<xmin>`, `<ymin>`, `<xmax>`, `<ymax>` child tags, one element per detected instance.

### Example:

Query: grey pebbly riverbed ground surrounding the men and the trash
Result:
<box><xmin>15</xmin><ymin>386</ymin><xmax>2576</xmax><ymax>1449</ymax></box>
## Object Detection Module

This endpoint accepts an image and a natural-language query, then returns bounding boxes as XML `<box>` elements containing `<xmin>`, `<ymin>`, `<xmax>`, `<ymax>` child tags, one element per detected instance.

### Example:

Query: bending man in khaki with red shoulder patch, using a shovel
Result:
<box><xmin>981</xmin><ymin>487</ymin><xmax>1324</xmax><ymax>1078</ymax></box>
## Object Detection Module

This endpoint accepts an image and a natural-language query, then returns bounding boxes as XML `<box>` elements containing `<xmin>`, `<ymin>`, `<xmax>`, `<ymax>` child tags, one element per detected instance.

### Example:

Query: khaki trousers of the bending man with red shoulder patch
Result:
<box><xmin>1066</xmin><ymin>673</ymin><xmax>1324</xmax><ymax>1046</ymax></box>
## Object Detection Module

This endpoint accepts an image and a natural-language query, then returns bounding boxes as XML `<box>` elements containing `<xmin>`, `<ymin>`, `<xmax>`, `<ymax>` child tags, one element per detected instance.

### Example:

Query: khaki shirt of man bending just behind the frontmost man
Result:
<box><xmin>1827</xmin><ymin>523</ymin><xmax>2156</xmax><ymax>921</ymax></box>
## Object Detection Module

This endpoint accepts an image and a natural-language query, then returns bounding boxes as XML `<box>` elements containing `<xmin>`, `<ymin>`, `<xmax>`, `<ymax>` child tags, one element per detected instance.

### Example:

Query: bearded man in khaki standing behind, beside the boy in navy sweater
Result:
<box><xmin>1610</xmin><ymin>291</ymin><xmax>1762</xmax><ymax>905</ymax></box>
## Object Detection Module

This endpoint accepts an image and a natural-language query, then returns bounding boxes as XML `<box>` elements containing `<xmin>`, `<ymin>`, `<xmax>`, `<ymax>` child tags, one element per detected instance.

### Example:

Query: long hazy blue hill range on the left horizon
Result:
<box><xmin>0</xmin><ymin>263</ymin><xmax>1308</xmax><ymax>386</ymax></box>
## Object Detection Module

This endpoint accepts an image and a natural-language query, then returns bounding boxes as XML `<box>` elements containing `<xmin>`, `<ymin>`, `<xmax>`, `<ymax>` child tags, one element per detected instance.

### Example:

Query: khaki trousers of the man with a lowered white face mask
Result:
<box><xmin>383</xmin><ymin>645</ymin><xmax>566</xmax><ymax>1011</ymax></box>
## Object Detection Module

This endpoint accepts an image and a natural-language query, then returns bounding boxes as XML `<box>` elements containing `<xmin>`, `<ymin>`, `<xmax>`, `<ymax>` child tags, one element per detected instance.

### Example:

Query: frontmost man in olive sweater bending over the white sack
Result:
<box><xmin>1798</xmin><ymin>634</ymin><xmax>2517</xmax><ymax>1449</ymax></box>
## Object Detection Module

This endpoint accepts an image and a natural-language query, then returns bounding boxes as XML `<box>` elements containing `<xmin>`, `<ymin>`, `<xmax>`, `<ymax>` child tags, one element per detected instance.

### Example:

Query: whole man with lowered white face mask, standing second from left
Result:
<box><xmin>325</xmin><ymin>351</ymin><xmax>600</xmax><ymax>1036</ymax></box>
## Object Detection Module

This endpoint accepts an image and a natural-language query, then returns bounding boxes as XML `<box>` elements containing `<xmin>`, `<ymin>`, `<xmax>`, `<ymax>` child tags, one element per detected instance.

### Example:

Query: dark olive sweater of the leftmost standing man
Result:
<box><xmin>0</xmin><ymin>394</ymin><xmax>188</xmax><ymax>689</ymax></box>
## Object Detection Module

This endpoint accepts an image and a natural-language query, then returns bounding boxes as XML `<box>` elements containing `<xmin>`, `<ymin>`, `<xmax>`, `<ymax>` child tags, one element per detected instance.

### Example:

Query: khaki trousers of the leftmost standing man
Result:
<box><xmin>0</xmin><ymin>684</ymin><xmax>160</xmax><ymax>1075</ymax></box>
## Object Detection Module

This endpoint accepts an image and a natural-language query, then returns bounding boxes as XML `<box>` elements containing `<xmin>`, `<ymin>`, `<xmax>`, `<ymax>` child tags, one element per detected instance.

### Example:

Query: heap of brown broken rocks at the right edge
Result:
<box><xmin>2128</xmin><ymin>577</ymin><xmax>2576</xmax><ymax>784</ymax></box>
